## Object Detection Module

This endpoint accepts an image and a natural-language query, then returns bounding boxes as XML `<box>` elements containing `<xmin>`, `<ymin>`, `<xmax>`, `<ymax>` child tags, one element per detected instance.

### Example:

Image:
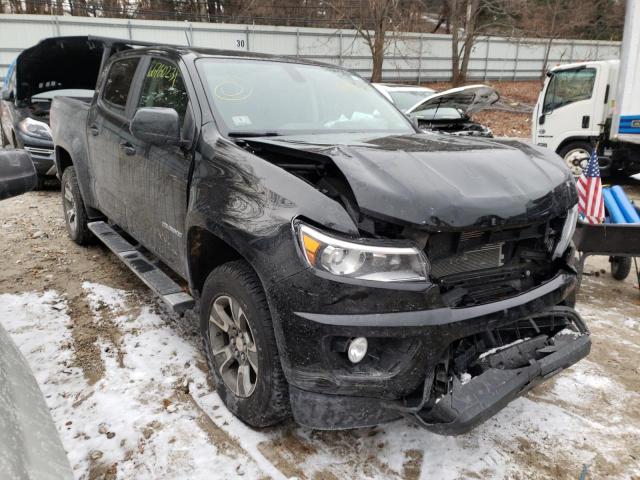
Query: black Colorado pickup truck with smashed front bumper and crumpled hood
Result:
<box><xmin>51</xmin><ymin>39</ymin><xmax>590</xmax><ymax>434</ymax></box>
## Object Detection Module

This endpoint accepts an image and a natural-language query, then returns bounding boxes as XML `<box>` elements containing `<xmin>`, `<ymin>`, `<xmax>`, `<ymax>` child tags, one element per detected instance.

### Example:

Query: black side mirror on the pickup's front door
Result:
<box><xmin>129</xmin><ymin>107</ymin><xmax>180</xmax><ymax>145</ymax></box>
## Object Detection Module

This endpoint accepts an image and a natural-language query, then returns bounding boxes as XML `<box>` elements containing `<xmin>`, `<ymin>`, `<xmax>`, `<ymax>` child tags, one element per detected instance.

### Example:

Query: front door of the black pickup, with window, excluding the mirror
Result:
<box><xmin>125</xmin><ymin>57</ymin><xmax>195</xmax><ymax>273</ymax></box>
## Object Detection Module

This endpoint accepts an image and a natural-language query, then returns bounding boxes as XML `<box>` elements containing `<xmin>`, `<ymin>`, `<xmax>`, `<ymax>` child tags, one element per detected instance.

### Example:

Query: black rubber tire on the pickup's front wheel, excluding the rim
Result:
<box><xmin>200</xmin><ymin>260</ymin><xmax>291</xmax><ymax>427</ymax></box>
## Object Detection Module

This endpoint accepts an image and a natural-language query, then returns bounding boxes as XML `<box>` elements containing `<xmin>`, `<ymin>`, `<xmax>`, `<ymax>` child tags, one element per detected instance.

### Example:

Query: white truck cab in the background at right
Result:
<box><xmin>532</xmin><ymin>60</ymin><xmax>620</xmax><ymax>175</ymax></box>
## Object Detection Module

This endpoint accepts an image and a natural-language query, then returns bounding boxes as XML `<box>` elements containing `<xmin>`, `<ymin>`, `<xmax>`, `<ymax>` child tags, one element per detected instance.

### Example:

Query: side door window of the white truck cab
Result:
<box><xmin>542</xmin><ymin>68</ymin><xmax>596</xmax><ymax>113</ymax></box>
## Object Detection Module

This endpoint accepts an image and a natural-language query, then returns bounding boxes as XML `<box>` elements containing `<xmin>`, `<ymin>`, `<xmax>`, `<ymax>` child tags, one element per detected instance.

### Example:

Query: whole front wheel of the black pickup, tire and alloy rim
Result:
<box><xmin>200</xmin><ymin>260</ymin><xmax>291</xmax><ymax>427</ymax></box>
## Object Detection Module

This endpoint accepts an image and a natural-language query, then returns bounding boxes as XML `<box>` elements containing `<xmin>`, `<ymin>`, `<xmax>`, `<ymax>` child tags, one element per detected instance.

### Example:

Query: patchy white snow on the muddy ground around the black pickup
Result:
<box><xmin>0</xmin><ymin>282</ymin><xmax>640</xmax><ymax>479</ymax></box>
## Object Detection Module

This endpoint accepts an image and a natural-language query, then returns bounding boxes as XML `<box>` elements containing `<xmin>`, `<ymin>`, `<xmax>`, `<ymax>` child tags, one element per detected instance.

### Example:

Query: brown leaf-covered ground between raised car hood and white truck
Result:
<box><xmin>424</xmin><ymin>81</ymin><xmax>542</xmax><ymax>138</ymax></box>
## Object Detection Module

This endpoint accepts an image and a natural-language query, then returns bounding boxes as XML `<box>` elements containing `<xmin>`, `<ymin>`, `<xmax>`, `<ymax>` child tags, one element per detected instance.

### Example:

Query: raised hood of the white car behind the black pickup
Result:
<box><xmin>406</xmin><ymin>85</ymin><xmax>500</xmax><ymax>115</ymax></box>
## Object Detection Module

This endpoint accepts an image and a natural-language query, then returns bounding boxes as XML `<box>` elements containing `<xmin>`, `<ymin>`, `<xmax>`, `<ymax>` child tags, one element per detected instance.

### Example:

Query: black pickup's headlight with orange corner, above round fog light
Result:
<box><xmin>298</xmin><ymin>225</ymin><xmax>428</xmax><ymax>282</ymax></box>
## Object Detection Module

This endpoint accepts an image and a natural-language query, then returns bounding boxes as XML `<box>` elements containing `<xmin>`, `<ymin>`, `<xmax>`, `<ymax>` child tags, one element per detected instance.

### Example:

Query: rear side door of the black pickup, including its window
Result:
<box><xmin>87</xmin><ymin>57</ymin><xmax>140</xmax><ymax>229</ymax></box>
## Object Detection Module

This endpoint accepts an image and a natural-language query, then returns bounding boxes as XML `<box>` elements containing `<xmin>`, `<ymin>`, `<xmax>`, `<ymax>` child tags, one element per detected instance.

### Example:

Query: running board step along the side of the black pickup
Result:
<box><xmin>87</xmin><ymin>222</ymin><xmax>194</xmax><ymax>314</ymax></box>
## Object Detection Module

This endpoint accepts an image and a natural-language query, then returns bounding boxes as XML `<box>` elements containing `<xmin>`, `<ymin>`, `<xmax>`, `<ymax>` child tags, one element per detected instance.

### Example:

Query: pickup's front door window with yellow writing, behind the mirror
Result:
<box><xmin>138</xmin><ymin>58</ymin><xmax>189</xmax><ymax>121</ymax></box>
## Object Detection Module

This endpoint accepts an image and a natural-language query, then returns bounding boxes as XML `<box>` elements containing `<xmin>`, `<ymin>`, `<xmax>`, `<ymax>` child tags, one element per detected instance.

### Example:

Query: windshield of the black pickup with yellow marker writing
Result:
<box><xmin>197</xmin><ymin>58</ymin><xmax>414</xmax><ymax>136</ymax></box>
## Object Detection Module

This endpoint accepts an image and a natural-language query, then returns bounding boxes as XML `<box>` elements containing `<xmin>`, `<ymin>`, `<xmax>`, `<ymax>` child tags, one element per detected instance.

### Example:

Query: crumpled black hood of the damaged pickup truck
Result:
<box><xmin>245</xmin><ymin>133</ymin><xmax>577</xmax><ymax>230</ymax></box>
